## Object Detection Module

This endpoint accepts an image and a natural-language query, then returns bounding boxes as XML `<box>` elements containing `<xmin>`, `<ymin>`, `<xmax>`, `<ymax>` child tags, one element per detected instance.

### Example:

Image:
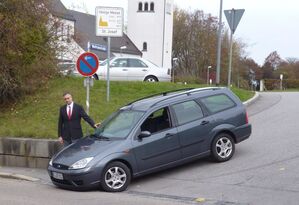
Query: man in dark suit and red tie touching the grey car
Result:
<box><xmin>58</xmin><ymin>92</ymin><xmax>97</xmax><ymax>146</ymax></box>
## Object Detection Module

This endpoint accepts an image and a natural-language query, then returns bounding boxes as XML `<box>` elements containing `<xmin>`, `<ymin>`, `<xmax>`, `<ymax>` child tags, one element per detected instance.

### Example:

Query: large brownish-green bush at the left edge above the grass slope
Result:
<box><xmin>0</xmin><ymin>0</ymin><xmax>57</xmax><ymax>104</ymax></box>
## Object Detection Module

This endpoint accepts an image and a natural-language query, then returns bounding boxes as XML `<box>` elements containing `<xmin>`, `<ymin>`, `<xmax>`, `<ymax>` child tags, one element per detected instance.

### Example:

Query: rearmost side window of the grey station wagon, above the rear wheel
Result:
<box><xmin>200</xmin><ymin>94</ymin><xmax>236</xmax><ymax>113</ymax></box>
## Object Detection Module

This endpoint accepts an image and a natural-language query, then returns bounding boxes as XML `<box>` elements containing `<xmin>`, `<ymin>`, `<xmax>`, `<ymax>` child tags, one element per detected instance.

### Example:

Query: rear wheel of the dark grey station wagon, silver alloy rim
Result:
<box><xmin>212</xmin><ymin>133</ymin><xmax>235</xmax><ymax>162</ymax></box>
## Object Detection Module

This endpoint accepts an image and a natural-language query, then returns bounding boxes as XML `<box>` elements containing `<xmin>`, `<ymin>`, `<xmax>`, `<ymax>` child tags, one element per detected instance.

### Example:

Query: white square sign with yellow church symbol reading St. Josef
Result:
<box><xmin>96</xmin><ymin>7</ymin><xmax>124</xmax><ymax>37</ymax></box>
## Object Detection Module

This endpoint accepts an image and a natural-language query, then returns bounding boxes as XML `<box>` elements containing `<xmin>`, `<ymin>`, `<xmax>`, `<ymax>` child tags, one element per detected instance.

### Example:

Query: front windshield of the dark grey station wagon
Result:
<box><xmin>95</xmin><ymin>110</ymin><xmax>144</xmax><ymax>139</ymax></box>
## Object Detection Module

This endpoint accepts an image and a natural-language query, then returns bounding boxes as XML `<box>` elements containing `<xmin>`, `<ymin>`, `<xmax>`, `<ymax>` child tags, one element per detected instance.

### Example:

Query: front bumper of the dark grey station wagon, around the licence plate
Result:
<box><xmin>48</xmin><ymin>166</ymin><xmax>101</xmax><ymax>190</ymax></box>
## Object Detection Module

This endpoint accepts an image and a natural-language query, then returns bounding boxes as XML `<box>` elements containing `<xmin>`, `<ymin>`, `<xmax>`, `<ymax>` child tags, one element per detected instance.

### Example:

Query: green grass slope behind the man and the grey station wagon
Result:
<box><xmin>0</xmin><ymin>77</ymin><xmax>254</xmax><ymax>138</ymax></box>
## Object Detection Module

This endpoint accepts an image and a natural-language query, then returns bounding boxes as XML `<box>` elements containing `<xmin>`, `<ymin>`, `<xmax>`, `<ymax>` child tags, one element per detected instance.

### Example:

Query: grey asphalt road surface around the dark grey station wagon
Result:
<box><xmin>0</xmin><ymin>92</ymin><xmax>299</xmax><ymax>205</ymax></box>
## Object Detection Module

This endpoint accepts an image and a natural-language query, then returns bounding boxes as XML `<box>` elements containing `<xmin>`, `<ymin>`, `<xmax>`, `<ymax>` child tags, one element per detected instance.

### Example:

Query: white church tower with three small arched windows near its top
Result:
<box><xmin>127</xmin><ymin>0</ymin><xmax>173</xmax><ymax>69</ymax></box>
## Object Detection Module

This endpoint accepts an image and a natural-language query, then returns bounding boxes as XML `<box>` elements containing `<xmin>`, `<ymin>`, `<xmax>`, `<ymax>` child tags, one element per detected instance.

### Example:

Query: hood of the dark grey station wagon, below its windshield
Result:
<box><xmin>53</xmin><ymin>137</ymin><xmax>124</xmax><ymax>166</ymax></box>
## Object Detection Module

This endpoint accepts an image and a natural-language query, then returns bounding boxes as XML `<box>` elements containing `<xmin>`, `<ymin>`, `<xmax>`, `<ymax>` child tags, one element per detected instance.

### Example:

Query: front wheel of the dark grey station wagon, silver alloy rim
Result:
<box><xmin>101</xmin><ymin>162</ymin><xmax>131</xmax><ymax>192</ymax></box>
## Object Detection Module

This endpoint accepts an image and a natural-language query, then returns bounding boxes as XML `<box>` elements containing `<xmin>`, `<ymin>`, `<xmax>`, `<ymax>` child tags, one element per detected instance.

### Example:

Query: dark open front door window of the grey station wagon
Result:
<box><xmin>141</xmin><ymin>108</ymin><xmax>171</xmax><ymax>133</ymax></box>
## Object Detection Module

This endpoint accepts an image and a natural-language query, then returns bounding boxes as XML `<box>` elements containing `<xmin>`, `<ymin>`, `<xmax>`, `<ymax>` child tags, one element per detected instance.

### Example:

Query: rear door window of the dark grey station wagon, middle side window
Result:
<box><xmin>172</xmin><ymin>100</ymin><xmax>204</xmax><ymax>125</ymax></box>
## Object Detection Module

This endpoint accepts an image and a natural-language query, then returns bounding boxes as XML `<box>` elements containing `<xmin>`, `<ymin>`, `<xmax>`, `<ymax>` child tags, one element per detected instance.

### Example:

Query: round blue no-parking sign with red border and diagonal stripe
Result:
<box><xmin>77</xmin><ymin>52</ymin><xmax>99</xmax><ymax>76</ymax></box>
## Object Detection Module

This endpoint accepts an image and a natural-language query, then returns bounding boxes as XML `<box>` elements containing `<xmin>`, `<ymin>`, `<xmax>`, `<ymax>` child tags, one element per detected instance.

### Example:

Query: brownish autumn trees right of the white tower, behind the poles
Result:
<box><xmin>173</xmin><ymin>8</ymin><xmax>245</xmax><ymax>83</ymax></box>
